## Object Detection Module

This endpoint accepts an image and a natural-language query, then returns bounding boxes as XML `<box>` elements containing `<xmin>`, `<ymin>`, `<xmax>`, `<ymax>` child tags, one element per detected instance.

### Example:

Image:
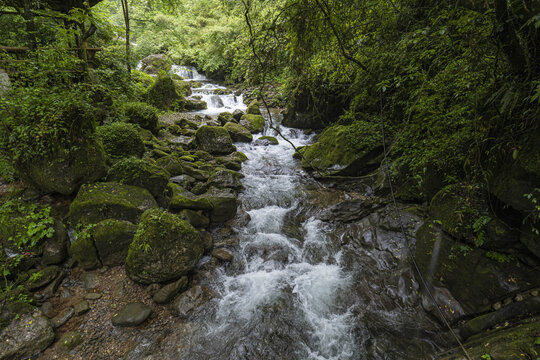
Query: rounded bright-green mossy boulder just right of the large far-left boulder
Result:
<box><xmin>97</xmin><ymin>122</ymin><xmax>145</xmax><ymax>160</ymax></box>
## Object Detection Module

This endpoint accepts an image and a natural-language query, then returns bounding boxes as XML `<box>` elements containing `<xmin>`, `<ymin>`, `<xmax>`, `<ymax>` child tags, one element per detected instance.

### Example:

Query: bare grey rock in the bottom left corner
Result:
<box><xmin>0</xmin><ymin>309</ymin><xmax>54</xmax><ymax>360</ymax></box>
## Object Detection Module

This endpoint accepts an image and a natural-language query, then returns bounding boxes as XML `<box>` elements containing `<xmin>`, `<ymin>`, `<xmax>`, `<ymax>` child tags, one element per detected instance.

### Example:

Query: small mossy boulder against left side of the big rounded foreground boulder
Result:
<box><xmin>90</xmin><ymin>219</ymin><xmax>137</xmax><ymax>266</ymax></box>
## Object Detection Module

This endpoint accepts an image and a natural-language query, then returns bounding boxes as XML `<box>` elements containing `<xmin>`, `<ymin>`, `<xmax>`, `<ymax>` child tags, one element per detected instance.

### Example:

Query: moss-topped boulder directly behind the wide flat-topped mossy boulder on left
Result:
<box><xmin>107</xmin><ymin>157</ymin><xmax>171</xmax><ymax>198</ymax></box>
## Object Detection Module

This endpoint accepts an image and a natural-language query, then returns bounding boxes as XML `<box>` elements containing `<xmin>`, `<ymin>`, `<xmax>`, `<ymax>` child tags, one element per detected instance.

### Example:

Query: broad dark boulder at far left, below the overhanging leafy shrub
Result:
<box><xmin>15</xmin><ymin>135</ymin><xmax>107</xmax><ymax>195</ymax></box>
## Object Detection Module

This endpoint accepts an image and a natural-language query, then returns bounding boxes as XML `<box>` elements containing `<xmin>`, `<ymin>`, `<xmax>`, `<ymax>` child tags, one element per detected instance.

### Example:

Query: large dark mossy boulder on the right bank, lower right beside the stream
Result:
<box><xmin>415</xmin><ymin>224</ymin><xmax>540</xmax><ymax>315</ymax></box>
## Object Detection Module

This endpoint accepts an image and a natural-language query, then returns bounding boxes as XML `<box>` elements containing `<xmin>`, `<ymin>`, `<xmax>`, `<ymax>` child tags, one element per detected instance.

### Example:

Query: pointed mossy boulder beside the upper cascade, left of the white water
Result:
<box><xmin>145</xmin><ymin>72</ymin><xmax>184</xmax><ymax>110</ymax></box>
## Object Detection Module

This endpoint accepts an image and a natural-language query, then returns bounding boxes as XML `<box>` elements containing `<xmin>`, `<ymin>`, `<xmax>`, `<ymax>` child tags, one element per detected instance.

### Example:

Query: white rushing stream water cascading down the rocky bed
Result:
<box><xmin>153</xmin><ymin>68</ymin><xmax>448</xmax><ymax>360</ymax></box>
